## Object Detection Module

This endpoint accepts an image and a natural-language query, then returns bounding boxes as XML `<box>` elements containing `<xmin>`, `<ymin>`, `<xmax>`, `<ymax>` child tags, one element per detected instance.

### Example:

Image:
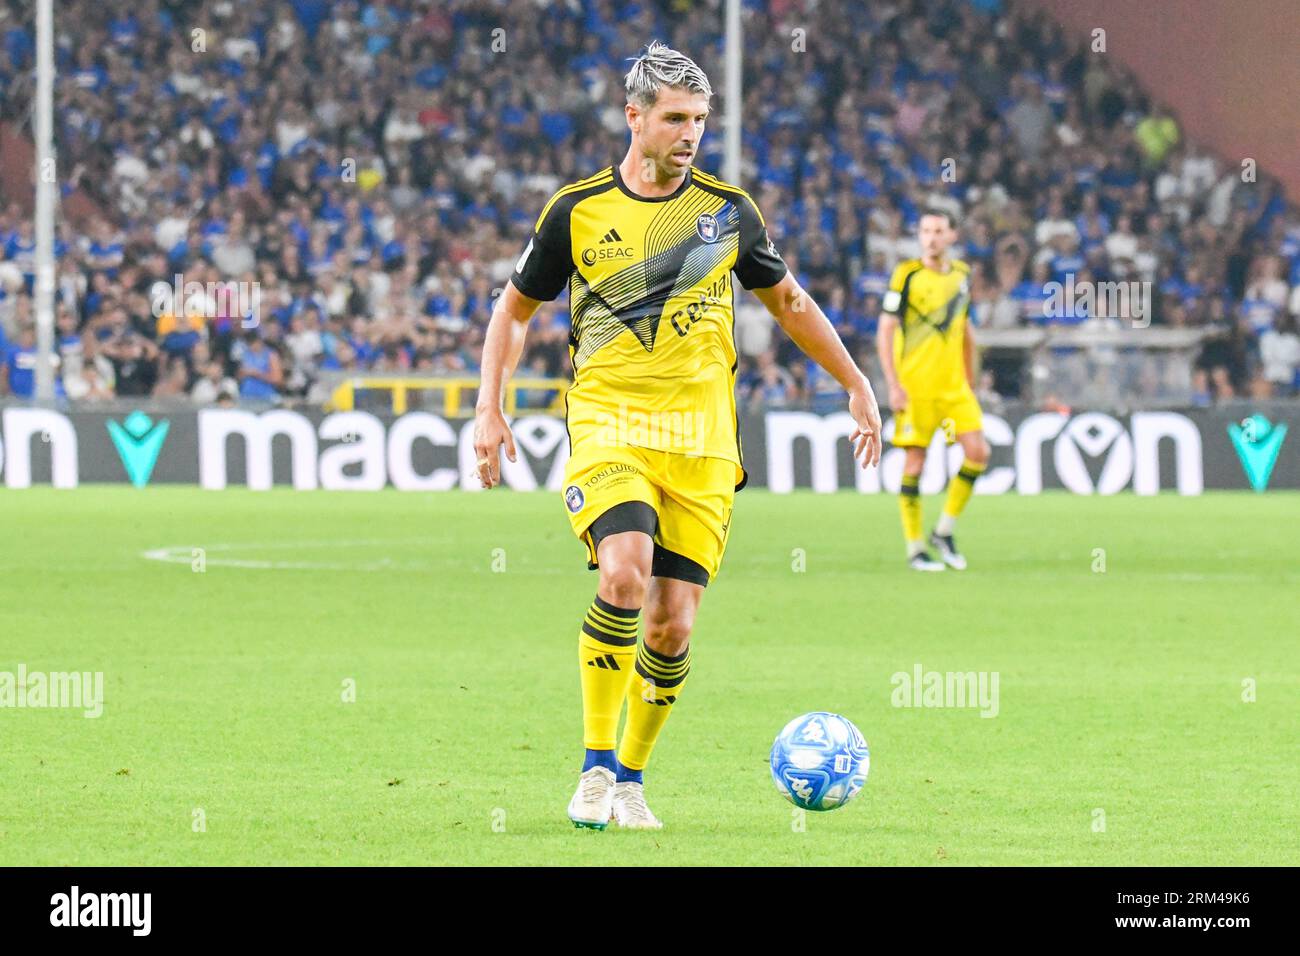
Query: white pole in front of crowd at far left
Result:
<box><xmin>34</xmin><ymin>0</ymin><xmax>59</xmax><ymax>403</ymax></box>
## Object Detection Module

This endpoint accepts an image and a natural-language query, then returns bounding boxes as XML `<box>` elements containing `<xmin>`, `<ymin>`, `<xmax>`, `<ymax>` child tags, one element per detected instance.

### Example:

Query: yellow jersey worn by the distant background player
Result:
<box><xmin>881</xmin><ymin>259</ymin><xmax>971</xmax><ymax>399</ymax></box>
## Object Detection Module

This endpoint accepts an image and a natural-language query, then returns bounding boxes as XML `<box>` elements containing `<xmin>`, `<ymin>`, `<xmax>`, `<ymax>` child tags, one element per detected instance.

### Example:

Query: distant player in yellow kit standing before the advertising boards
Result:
<box><xmin>876</xmin><ymin>209</ymin><xmax>988</xmax><ymax>571</ymax></box>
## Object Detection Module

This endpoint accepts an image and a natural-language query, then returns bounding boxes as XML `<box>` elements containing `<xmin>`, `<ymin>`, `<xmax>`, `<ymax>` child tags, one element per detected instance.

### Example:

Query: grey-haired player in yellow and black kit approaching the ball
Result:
<box><xmin>475</xmin><ymin>43</ymin><xmax>880</xmax><ymax>830</ymax></box>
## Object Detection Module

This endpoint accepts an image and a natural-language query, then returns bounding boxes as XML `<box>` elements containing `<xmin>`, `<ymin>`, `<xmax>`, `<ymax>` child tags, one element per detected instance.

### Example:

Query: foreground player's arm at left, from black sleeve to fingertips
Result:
<box><xmin>475</xmin><ymin>194</ymin><xmax>573</xmax><ymax>488</ymax></box>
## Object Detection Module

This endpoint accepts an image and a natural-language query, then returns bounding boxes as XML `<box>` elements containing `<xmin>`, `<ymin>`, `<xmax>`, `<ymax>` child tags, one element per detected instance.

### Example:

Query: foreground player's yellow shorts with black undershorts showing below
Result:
<box><xmin>564</xmin><ymin>445</ymin><xmax>736</xmax><ymax>585</ymax></box>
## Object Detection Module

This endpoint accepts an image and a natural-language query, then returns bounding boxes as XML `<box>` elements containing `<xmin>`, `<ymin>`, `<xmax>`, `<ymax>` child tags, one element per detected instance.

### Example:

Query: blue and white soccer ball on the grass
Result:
<box><xmin>772</xmin><ymin>710</ymin><xmax>871</xmax><ymax>810</ymax></box>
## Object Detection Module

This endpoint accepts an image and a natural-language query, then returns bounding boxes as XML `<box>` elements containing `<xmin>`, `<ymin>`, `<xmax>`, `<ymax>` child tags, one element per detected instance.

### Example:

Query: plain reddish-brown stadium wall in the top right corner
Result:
<box><xmin>1023</xmin><ymin>0</ymin><xmax>1300</xmax><ymax>200</ymax></box>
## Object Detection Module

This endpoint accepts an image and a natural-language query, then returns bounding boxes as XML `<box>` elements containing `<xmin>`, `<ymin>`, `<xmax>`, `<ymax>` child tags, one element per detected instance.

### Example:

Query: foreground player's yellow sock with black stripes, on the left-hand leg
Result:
<box><xmin>577</xmin><ymin>594</ymin><xmax>641</xmax><ymax>754</ymax></box>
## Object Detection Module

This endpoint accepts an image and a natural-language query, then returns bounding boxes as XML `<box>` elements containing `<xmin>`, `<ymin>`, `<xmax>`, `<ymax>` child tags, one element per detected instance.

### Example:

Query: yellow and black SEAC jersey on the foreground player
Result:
<box><xmin>511</xmin><ymin>166</ymin><xmax>787</xmax><ymax>488</ymax></box>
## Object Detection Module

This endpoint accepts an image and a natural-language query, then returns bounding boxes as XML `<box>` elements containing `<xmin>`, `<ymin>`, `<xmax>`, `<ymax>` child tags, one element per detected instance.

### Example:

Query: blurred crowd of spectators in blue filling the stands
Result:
<box><xmin>0</xmin><ymin>0</ymin><xmax>1300</xmax><ymax>406</ymax></box>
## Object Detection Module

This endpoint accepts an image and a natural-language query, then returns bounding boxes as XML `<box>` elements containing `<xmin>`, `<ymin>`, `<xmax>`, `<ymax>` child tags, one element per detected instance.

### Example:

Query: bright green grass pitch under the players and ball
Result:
<box><xmin>0</xmin><ymin>486</ymin><xmax>1300</xmax><ymax>866</ymax></box>
